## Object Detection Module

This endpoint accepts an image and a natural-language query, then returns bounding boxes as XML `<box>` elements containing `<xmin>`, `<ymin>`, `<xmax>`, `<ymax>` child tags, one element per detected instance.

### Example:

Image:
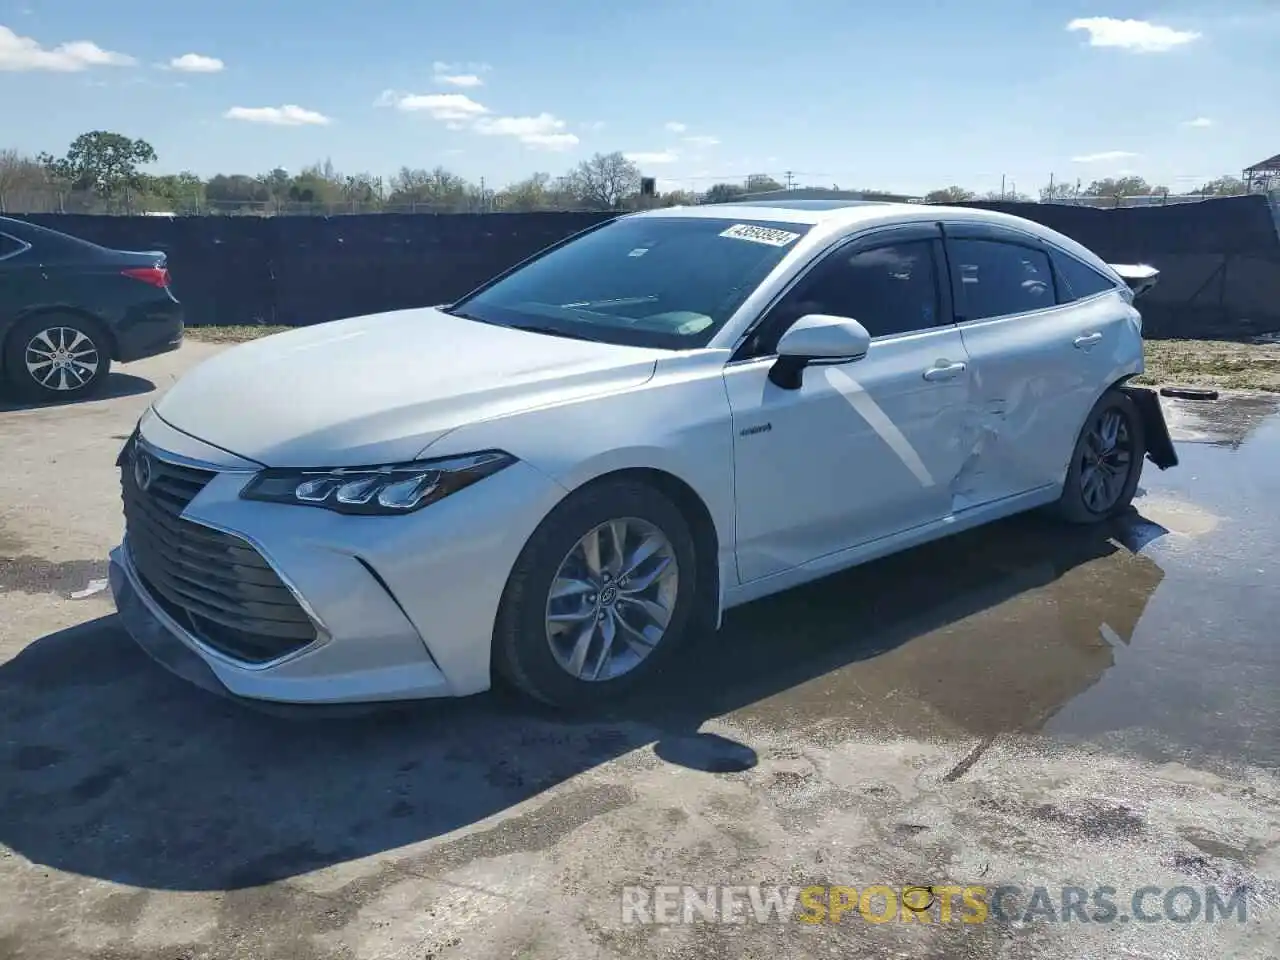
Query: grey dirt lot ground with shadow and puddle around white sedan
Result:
<box><xmin>0</xmin><ymin>342</ymin><xmax>1280</xmax><ymax>960</ymax></box>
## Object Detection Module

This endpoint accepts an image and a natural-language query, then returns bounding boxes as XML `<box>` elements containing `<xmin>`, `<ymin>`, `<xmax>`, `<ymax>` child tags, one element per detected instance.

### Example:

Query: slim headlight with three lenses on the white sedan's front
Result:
<box><xmin>241</xmin><ymin>451</ymin><xmax>516</xmax><ymax>517</ymax></box>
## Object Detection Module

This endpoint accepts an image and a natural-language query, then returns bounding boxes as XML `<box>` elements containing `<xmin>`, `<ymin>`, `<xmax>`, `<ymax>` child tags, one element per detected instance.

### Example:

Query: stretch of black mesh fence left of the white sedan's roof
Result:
<box><xmin>17</xmin><ymin>212</ymin><xmax>614</xmax><ymax>326</ymax></box>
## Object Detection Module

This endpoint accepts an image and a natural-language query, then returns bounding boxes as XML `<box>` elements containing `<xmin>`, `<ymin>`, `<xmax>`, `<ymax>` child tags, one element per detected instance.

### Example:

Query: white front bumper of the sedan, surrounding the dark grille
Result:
<box><xmin>110</xmin><ymin>413</ymin><xmax>563</xmax><ymax>704</ymax></box>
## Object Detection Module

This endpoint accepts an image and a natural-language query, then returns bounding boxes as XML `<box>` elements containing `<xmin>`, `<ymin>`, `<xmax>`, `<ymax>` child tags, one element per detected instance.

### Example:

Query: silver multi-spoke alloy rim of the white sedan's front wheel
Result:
<box><xmin>547</xmin><ymin>517</ymin><xmax>680</xmax><ymax>681</ymax></box>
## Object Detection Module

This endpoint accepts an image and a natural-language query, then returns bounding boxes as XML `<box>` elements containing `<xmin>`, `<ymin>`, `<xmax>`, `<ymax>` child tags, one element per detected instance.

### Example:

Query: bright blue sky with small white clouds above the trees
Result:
<box><xmin>0</xmin><ymin>0</ymin><xmax>1280</xmax><ymax>192</ymax></box>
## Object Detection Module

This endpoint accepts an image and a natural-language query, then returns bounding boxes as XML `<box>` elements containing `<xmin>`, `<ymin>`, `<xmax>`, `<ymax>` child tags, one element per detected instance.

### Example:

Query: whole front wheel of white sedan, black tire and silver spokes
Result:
<box><xmin>493</xmin><ymin>479</ymin><xmax>698</xmax><ymax>709</ymax></box>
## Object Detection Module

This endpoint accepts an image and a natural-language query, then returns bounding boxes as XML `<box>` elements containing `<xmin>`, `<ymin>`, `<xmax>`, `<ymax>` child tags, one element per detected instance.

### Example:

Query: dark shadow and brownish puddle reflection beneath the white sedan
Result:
<box><xmin>0</xmin><ymin>515</ymin><xmax>1164</xmax><ymax>891</ymax></box>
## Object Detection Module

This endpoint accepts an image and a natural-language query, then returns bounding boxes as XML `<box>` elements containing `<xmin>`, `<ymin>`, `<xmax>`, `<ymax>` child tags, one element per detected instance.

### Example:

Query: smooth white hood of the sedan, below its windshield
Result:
<box><xmin>155</xmin><ymin>307</ymin><xmax>663</xmax><ymax>467</ymax></box>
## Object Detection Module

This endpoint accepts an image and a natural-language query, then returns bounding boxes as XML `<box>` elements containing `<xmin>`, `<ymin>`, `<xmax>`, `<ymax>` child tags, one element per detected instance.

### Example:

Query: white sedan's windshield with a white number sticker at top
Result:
<box><xmin>449</xmin><ymin>216</ymin><xmax>809</xmax><ymax>349</ymax></box>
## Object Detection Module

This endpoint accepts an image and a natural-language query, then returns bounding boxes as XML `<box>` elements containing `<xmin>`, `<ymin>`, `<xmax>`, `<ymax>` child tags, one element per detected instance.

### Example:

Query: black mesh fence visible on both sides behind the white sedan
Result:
<box><xmin>20</xmin><ymin>196</ymin><xmax>1280</xmax><ymax>338</ymax></box>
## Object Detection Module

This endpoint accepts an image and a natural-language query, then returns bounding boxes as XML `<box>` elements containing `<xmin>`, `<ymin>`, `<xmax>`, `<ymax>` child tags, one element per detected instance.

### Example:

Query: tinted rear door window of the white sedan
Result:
<box><xmin>947</xmin><ymin>239</ymin><xmax>1056</xmax><ymax>323</ymax></box>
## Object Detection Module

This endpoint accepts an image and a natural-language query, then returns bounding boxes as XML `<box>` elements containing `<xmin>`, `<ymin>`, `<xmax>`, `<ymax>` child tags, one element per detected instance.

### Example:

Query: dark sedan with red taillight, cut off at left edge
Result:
<box><xmin>0</xmin><ymin>216</ymin><xmax>183</xmax><ymax>402</ymax></box>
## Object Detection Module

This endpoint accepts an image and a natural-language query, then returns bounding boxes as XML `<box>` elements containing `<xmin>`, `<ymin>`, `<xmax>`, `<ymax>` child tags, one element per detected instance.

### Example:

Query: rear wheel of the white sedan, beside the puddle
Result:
<box><xmin>1056</xmin><ymin>389</ymin><xmax>1147</xmax><ymax>524</ymax></box>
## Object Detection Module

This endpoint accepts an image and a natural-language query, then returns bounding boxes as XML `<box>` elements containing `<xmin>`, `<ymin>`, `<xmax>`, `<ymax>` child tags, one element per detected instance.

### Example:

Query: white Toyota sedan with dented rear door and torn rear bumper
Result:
<box><xmin>110</xmin><ymin>202</ymin><xmax>1178</xmax><ymax>705</ymax></box>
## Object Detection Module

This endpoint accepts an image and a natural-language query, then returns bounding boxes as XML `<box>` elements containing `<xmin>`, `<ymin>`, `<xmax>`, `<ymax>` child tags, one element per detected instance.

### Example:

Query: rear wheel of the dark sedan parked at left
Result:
<box><xmin>0</xmin><ymin>314</ymin><xmax>111</xmax><ymax>403</ymax></box>
